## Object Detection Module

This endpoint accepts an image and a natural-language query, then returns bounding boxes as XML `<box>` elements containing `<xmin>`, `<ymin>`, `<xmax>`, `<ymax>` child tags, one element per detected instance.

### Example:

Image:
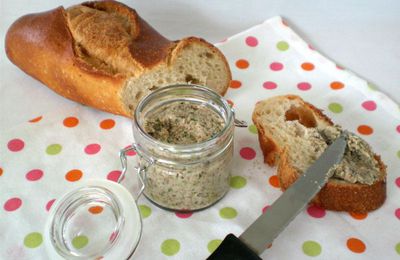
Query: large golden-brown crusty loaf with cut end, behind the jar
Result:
<box><xmin>5</xmin><ymin>1</ymin><xmax>231</xmax><ymax>116</ymax></box>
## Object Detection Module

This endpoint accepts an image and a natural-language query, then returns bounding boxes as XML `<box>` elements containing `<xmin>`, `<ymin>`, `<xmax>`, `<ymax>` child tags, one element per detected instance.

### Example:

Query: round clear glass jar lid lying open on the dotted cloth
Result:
<box><xmin>44</xmin><ymin>180</ymin><xmax>142</xmax><ymax>259</ymax></box>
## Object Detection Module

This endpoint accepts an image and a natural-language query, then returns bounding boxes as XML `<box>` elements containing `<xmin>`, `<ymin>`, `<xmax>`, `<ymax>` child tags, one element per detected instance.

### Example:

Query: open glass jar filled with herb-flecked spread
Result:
<box><xmin>122</xmin><ymin>85</ymin><xmax>234</xmax><ymax>211</ymax></box>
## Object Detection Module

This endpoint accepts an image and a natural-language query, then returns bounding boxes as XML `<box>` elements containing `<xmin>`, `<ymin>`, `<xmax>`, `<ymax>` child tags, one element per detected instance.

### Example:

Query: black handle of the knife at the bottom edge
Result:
<box><xmin>207</xmin><ymin>234</ymin><xmax>262</xmax><ymax>260</ymax></box>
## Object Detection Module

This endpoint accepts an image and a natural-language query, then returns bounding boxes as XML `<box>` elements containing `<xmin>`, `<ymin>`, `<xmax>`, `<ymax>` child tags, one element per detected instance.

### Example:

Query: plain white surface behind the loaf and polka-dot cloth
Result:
<box><xmin>0</xmin><ymin>0</ymin><xmax>400</xmax><ymax>126</ymax></box>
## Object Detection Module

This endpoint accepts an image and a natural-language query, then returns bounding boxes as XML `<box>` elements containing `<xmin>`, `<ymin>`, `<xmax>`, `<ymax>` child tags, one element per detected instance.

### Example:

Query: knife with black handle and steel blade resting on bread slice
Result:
<box><xmin>207</xmin><ymin>133</ymin><xmax>347</xmax><ymax>260</ymax></box>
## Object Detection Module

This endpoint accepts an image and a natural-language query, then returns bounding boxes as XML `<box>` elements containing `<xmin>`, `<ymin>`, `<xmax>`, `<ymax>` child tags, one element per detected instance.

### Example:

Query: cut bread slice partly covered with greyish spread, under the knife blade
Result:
<box><xmin>252</xmin><ymin>95</ymin><xmax>386</xmax><ymax>213</ymax></box>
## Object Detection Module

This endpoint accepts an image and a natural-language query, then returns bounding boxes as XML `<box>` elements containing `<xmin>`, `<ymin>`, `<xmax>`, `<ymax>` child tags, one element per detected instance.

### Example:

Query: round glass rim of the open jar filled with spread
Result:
<box><xmin>134</xmin><ymin>84</ymin><xmax>234</xmax><ymax>153</ymax></box>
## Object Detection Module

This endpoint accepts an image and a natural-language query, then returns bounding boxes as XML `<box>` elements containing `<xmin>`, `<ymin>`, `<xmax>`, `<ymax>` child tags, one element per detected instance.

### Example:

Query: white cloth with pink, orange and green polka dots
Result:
<box><xmin>0</xmin><ymin>17</ymin><xmax>400</xmax><ymax>259</ymax></box>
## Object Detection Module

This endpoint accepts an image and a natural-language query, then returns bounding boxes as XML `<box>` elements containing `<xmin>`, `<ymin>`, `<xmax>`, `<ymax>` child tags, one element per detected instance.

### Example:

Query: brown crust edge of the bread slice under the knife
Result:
<box><xmin>253</xmin><ymin>95</ymin><xmax>386</xmax><ymax>213</ymax></box>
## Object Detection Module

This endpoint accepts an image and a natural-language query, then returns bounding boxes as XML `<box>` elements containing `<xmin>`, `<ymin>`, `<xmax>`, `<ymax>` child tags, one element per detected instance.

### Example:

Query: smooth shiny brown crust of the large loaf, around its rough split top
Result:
<box><xmin>5</xmin><ymin>1</ymin><xmax>231</xmax><ymax>117</ymax></box>
